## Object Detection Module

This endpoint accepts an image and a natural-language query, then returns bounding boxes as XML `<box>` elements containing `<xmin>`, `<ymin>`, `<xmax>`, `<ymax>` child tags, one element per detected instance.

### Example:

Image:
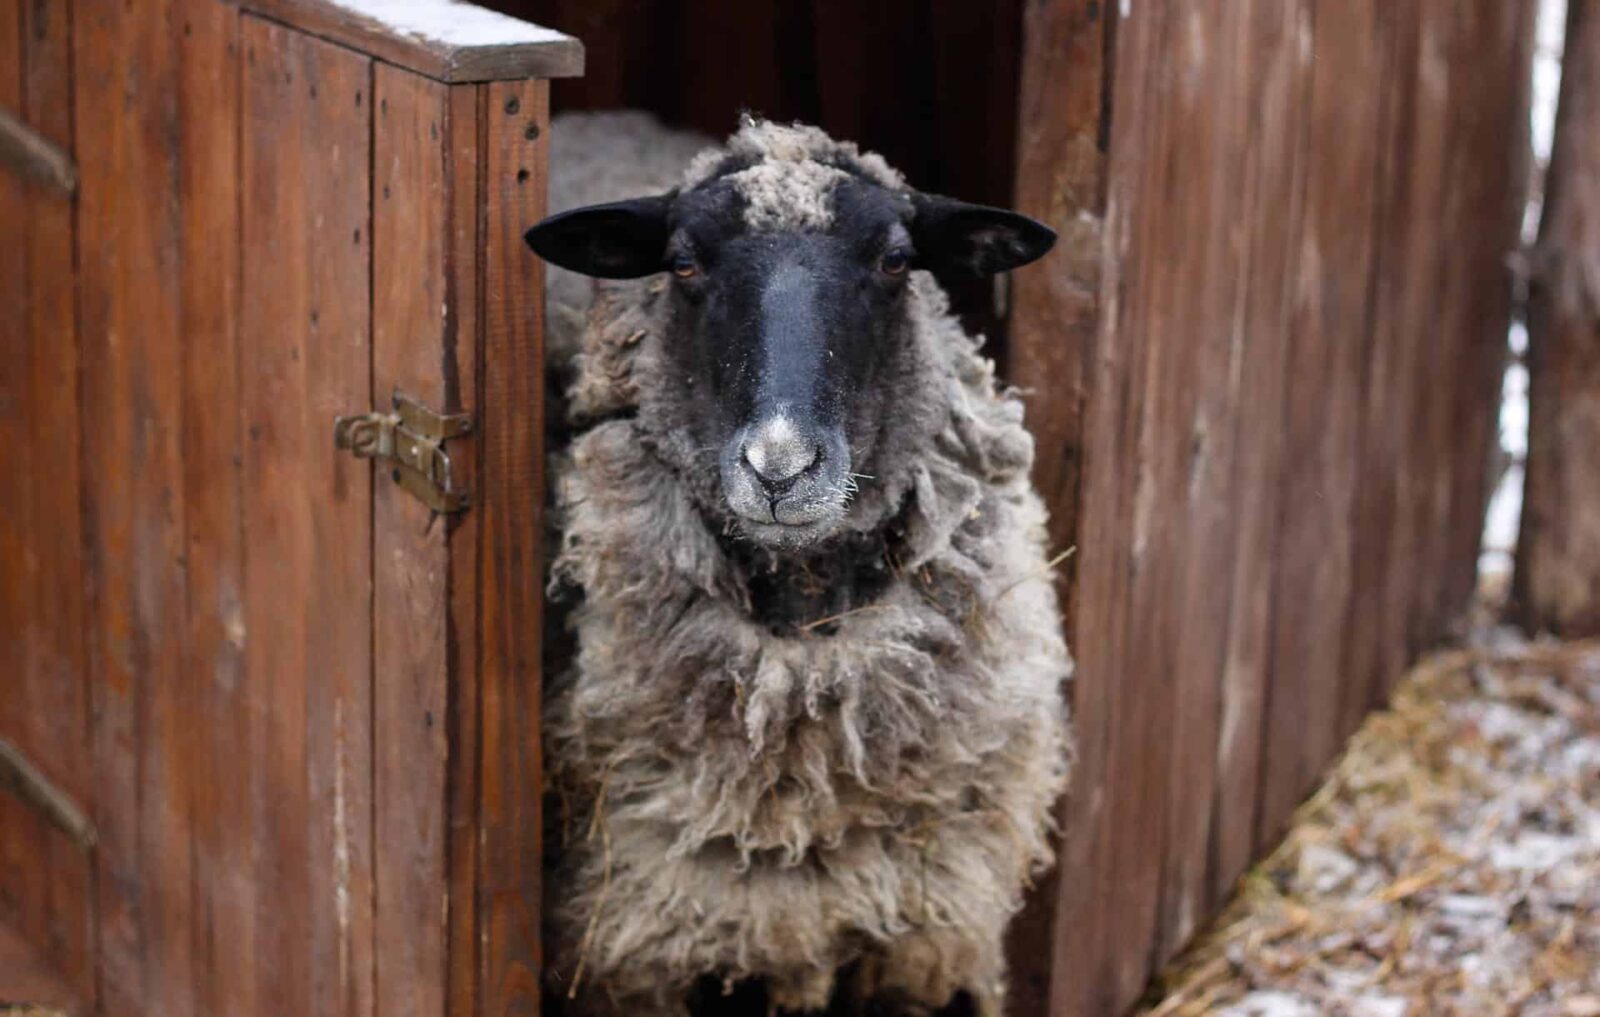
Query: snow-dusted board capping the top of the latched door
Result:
<box><xmin>243</xmin><ymin>0</ymin><xmax>584</xmax><ymax>82</ymax></box>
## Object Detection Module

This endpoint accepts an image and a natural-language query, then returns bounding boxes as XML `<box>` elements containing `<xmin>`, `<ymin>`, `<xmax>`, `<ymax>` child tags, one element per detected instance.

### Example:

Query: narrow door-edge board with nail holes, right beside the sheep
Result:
<box><xmin>477</xmin><ymin>82</ymin><xmax>549</xmax><ymax>1017</ymax></box>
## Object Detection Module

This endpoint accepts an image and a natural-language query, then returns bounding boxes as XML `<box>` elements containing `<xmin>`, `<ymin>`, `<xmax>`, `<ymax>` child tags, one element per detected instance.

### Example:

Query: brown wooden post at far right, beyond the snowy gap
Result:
<box><xmin>1514</xmin><ymin>0</ymin><xmax>1600</xmax><ymax>638</ymax></box>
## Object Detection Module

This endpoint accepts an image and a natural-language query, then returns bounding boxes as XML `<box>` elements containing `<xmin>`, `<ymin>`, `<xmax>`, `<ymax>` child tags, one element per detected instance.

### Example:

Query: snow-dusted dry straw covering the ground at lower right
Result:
<box><xmin>1141</xmin><ymin>636</ymin><xmax>1600</xmax><ymax>1017</ymax></box>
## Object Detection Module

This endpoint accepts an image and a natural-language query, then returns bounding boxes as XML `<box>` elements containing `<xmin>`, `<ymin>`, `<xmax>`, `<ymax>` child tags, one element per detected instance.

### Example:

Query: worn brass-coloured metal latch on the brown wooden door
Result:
<box><xmin>333</xmin><ymin>390</ymin><xmax>472</xmax><ymax>512</ymax></box>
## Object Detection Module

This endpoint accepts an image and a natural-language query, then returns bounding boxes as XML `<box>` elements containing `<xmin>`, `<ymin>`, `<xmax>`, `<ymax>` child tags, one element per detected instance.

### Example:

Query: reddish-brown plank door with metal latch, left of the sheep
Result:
<box><xmin>0</xmin><ymin>0</ymin><xmax>581</xmax><ymax>1017</ymax></box>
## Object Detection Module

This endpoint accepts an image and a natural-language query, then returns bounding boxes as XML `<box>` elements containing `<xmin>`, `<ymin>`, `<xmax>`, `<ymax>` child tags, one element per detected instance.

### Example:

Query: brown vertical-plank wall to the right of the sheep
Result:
<box><xmin>1011</xmin><ymin>0</ymin><xmax>1534</xmax><ymax>1017</ymax></box>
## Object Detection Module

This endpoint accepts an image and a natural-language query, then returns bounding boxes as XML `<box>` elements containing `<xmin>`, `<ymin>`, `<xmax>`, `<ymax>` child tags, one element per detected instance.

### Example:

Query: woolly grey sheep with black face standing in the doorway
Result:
<box><xmin>528</xmin><ymin>118</ymin><xmax>1072</xmax><ymax>1017</ymax></box>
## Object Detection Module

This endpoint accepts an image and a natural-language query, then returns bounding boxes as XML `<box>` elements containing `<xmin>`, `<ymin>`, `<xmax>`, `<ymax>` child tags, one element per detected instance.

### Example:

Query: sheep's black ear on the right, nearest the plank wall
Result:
<box><xmin>910</xmin><ymin>193</ymin><xmax>1056</xmax><ymax>275</ymax></box>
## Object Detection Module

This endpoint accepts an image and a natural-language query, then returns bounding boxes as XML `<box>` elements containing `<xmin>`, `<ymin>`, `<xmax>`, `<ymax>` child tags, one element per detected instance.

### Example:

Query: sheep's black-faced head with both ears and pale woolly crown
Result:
<box><xmin>526</xmin><ymin>120</ymin><xmax>1054</xmax><ymax>548</ymax></box>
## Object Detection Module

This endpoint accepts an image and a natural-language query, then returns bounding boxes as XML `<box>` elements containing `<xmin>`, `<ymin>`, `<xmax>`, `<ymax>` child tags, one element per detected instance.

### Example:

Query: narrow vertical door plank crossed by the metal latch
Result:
<box><xmin>373</xmin><ymin>66</ymin><xmax>454</xmax><ymax>1017</ymax></box>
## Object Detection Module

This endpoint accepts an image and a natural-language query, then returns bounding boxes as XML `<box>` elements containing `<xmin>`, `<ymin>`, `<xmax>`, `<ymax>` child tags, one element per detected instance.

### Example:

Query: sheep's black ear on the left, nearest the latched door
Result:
<box><xmin>523</xmin><ymin>193</ymin><xmax>674</xmax><ymax>278</ymax></box>
